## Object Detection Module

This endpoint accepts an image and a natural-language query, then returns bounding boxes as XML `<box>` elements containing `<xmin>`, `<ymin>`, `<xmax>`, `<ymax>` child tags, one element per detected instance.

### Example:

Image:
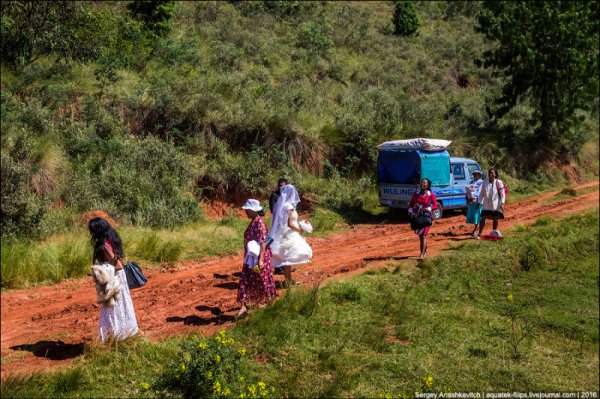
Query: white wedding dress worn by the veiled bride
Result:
<box><xmin>271</xmin><ymin>204</ymin><xmax>312</xmax><ymax>267</ymax></box>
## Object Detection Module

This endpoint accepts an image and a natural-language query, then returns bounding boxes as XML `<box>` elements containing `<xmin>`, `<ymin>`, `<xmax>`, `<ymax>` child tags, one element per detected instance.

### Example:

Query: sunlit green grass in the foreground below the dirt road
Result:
<box><xmin>2</xmin><ymin>212</ymin><xmax>599</xmax><ymax>397</ymax></box>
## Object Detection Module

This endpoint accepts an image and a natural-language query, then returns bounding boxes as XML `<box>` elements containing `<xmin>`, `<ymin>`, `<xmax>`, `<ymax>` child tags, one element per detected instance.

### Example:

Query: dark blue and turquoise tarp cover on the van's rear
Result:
<box><xmin>377</xmin><ymin>150</ymin><xmax>450</xmax><ymax>186</ymax></box>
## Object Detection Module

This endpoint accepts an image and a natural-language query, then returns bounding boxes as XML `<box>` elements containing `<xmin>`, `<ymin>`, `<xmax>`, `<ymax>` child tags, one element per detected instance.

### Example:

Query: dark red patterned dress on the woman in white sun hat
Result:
<box><xmin>238</xmin><ymin>216</ymin><xmax>277</xmax><ymax>304</ymax></box>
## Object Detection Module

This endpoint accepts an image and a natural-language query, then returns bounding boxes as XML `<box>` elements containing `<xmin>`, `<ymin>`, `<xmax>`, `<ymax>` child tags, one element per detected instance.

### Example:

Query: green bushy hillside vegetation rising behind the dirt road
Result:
<box><xmin>1</xmin><ymin>1</ymin><xmax>598</xmax><ymax>238</ymax></box>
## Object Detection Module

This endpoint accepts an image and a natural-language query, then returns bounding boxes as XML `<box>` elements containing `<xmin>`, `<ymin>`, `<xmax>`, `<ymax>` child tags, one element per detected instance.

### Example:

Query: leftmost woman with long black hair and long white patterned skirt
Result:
<box><xmin>88</xmin><ymin>217</ymin><xmax>139</xmax><ymax>342</ymax></box>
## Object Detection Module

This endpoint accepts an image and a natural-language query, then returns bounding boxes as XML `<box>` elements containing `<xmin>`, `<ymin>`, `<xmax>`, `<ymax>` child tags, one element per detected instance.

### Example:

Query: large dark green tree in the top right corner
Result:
<box><xmin>477</xmin><ymin>1</ymin><xmax>599</xmax><ymax>166</ymax></box>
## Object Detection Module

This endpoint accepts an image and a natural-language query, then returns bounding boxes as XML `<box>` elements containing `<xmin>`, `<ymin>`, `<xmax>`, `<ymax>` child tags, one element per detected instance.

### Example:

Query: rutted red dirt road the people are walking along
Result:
<box><xmin>1</xmin><ymin>182</ymin><xmax>599</xmax><ymax>376</ymax></box>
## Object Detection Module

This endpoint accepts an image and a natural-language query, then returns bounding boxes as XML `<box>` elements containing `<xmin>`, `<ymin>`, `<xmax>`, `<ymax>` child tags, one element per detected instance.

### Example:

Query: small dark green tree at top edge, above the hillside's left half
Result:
<box><xmin>127</xmin><ymin>0</ymin><xmax>175</xmax><ymax>36</ymax></box>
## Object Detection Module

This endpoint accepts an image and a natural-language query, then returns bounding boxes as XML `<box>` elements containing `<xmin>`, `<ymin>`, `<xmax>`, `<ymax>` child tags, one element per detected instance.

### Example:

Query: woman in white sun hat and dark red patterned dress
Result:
<box><xmin>236</xmin><ymin>199</ymin><xmax>277</xmax><ymax>317</ymax></box>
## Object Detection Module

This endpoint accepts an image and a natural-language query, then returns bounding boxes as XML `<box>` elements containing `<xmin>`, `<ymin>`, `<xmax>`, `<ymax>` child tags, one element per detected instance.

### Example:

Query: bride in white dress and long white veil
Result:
<box><xmin>269</xmin><ymin>184</ymin><xmax>312</xmax><ymax>285</ymax></box>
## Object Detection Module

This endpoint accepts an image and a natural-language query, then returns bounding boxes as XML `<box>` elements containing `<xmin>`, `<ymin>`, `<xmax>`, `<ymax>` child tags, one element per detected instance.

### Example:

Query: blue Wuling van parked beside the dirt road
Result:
<box><xmin>377</xmin><ymin>148</ymin><xmax>479</xmax><ymax>219</ymax></box>
